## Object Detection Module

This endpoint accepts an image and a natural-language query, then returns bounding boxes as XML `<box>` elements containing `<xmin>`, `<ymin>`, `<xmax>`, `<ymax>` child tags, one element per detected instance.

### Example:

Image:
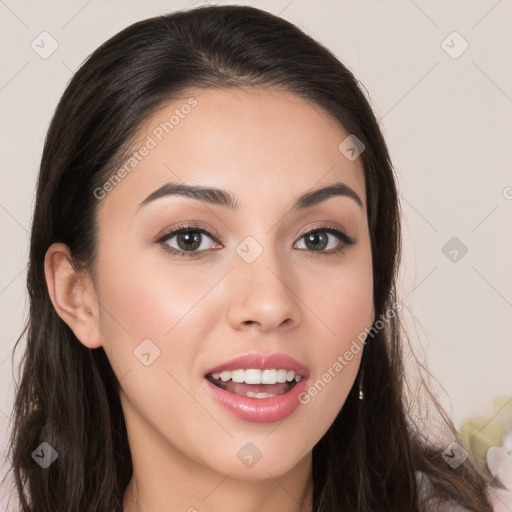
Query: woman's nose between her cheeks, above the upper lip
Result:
<box><xmin>227</xmin><ymin>243</ymin><xmax>301</xmax><ymax>332</ymax></box>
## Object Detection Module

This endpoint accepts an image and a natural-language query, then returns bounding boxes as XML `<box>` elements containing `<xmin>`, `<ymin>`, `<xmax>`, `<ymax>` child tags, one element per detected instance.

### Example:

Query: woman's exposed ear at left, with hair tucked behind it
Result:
<box><xmin>44</xmin><ymin>243</ymin><xmax>103</xmax><ymax>349</ymax></box>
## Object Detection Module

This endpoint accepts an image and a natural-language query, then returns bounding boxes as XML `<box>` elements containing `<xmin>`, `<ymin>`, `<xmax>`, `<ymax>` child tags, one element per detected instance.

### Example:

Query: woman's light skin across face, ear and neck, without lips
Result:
<box><xmin>45</xmin><ymin>88</ymin><xmax>374</xmax><ymax>512</ymax></box>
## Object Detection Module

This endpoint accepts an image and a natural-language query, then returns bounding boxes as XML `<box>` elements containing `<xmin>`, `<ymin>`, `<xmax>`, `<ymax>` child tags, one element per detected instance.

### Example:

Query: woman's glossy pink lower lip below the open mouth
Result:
<box><xmin>204</xmin><ymin>378</ymin><xmax>307</xmax><ymax>423</ymax></box>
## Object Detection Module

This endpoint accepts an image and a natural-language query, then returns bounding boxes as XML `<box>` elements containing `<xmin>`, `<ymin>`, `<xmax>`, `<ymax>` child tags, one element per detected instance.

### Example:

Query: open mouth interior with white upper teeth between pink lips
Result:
<box><xmin>205</xmin><ymin>368</ymin><xmax>302</xmax><ymax>398</ymax></box>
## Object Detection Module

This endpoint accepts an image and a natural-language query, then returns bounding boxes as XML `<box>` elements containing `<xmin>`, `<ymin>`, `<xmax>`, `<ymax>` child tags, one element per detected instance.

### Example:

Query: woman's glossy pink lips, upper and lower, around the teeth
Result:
<box><xmin>204</xmin><ymin>354</ymin><xmax>309</xmax><ymax>423</ymax></box>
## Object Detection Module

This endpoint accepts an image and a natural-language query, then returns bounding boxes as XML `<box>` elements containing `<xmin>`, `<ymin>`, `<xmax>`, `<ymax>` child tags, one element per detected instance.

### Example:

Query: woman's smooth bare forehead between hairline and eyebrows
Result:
<box><xmin>97</xmin><ymin>88</ymin><xmax>365</xmax><ymax>216</ymax></box>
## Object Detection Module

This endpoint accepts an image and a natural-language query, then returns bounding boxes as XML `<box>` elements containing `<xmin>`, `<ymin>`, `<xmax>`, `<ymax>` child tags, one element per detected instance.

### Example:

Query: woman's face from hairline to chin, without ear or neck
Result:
<box><xmin>94</xmin><ymin>89</ymin><xmax>374</xmax><ymax>479</ymax></box>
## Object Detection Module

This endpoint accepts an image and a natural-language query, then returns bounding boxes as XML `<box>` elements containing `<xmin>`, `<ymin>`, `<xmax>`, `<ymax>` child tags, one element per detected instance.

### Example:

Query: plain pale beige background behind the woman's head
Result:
<box><xmin>0</xmin><ymin>0</ymin><xmax>512</xmax><ymax>500</ymax></box>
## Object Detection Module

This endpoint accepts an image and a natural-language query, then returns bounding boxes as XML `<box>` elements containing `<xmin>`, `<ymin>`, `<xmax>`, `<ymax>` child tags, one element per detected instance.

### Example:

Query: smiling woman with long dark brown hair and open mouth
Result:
<box><xmin>5</xmin><ymin>6</ymin><xmax>508</xmax><ymax>512</ymax></box>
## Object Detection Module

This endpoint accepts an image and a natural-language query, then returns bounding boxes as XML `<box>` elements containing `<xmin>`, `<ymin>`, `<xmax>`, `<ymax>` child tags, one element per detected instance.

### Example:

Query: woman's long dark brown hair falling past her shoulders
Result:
<box><xmin>5</xmin><ymin>6</ymin><xmax>500</xmax><ymax>512</ymax></box>
